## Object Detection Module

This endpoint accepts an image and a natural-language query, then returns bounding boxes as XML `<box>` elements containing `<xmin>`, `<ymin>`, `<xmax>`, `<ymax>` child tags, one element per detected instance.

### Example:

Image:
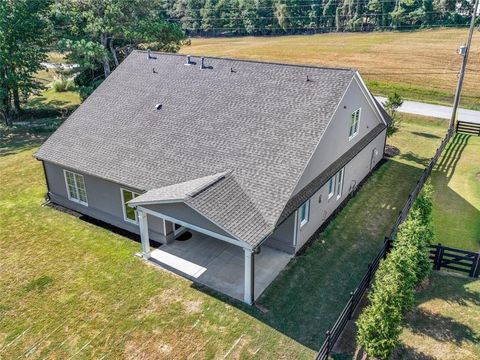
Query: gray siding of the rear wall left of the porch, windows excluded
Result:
<box><xmin>44</xmin><ymin>162</ymin><xmax>166</xmax><ymax>243</ymax></box>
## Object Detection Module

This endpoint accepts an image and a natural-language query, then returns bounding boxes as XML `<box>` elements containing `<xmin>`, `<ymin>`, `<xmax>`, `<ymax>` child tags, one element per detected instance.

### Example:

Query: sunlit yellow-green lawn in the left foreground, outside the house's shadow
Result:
<box><xmin>0</xmin><ymin>144</ymin><xmax>314</xmax><ymax>359</ymax></box>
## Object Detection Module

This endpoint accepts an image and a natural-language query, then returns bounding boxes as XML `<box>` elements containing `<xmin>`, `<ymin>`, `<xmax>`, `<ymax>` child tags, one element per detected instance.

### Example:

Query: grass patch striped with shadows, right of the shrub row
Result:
<box><xmin>396</xmin><ymin>273</ymin><xmax>480</xmax><ymax>360</ymax></box>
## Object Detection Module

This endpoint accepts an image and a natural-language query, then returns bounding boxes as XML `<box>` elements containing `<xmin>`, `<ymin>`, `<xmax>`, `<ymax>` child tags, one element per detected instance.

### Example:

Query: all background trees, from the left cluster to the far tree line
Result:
<box><xmin>0</xmin><ymin>0</ymin><xmax>472</xmax><ymax>124</ymax></box>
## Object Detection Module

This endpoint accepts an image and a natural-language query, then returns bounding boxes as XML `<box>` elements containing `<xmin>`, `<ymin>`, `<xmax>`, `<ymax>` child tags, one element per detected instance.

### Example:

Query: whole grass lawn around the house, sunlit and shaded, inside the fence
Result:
<box><xmin>0</xmin><ymin>116</ymin><xmax>472</xmax><ymax>359</ymax></box>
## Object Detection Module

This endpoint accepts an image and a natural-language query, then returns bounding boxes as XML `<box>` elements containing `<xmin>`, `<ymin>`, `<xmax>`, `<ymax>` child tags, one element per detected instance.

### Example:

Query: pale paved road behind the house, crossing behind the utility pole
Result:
<box><xmin>376</xmin><ymin>96</ymin><xmax>480</xmax><ymax>124</ymax></box>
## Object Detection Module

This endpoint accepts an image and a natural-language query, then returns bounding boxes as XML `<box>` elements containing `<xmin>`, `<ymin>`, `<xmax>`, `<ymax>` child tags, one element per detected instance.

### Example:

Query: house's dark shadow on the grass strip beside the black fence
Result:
<box><xmin>236</xmin><ymin>161</ymin><xmax>422</xmax><ymax>351</ymax></box>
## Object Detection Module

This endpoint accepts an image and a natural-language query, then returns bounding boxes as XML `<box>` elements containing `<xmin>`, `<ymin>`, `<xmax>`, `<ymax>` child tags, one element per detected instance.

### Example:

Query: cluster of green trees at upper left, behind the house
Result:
<box><xmin>0</xmin><ymin>0</ymin><xmax>185</xmax><ymax>125</ymax></box>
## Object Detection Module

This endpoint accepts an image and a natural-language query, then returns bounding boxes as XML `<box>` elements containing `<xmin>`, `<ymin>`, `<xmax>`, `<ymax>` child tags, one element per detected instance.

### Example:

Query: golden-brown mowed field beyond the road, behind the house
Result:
<box><xmin>180</xmin><ymin>29</ymin><xmax>480</xmax><ymax>109</ymax></box>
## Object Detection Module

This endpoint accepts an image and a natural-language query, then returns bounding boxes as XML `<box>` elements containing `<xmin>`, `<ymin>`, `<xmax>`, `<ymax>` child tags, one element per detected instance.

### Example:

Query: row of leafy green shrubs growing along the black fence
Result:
<box><xmin>357</xmin><ymin>184</ymin><xmax>433</xmax><ymax>359</ymax></box>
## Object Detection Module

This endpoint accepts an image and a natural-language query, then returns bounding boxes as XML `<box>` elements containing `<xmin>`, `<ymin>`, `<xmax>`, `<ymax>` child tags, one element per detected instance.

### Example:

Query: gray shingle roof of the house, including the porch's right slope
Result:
<box><xmin>37</xmin><ymin>51</ymin><xmax>355</xmax><ymax>248</ymax></box>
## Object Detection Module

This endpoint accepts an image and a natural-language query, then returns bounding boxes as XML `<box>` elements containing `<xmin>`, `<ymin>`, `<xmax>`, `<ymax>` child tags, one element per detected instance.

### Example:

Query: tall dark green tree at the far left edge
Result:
<box><xmin>0</xmin><ymin>0</ymin><xmax>51</xmax><ymax>125</ymax></box>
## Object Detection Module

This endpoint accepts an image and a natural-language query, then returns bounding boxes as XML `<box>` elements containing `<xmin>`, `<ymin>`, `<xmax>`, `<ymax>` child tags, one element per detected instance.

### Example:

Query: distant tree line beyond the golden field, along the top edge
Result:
<box><xmin>164</xmin><ymin>0</ymin><xmax>473</xmax><ymax>36</ymax></box>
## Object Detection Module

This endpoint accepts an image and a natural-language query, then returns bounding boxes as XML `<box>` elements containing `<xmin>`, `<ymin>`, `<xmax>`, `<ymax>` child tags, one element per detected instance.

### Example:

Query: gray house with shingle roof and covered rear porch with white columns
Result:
<box><xmin>36</xmin><ymin>51</ymin><xmax>389</xmax><ymax>304</ymax></box>
